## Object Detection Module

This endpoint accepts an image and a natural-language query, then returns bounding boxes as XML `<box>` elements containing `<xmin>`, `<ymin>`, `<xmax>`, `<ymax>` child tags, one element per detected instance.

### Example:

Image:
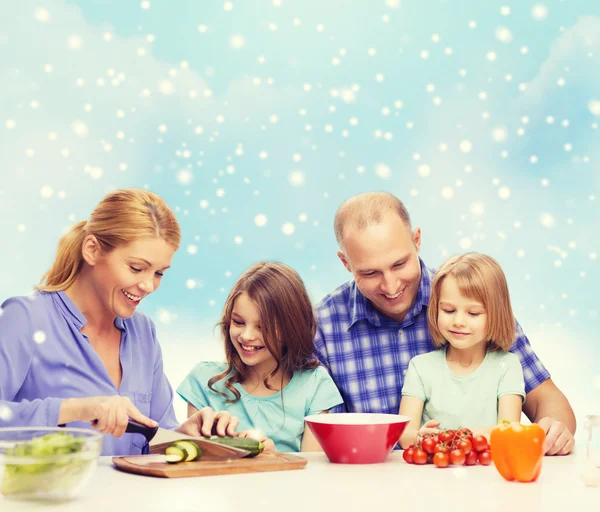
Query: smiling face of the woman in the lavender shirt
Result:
<box><xmin>84</xmin><ymin>238</ymin><xmax>175</xmax><ymax>318</ymax></box>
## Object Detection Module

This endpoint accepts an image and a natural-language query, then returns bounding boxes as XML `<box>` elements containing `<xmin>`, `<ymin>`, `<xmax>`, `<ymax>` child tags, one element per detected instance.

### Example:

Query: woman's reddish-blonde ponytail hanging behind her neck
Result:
<box><xmin>36</xmin><ymin>220</ymin><xmax>88</xmax><ymax>292</ymax></box>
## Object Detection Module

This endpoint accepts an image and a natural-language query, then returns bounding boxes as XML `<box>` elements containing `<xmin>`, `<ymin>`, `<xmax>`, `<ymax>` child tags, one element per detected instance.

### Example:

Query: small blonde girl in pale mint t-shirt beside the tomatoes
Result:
<box><xmin>400</xmin><ymin>253</ymin><xmax>525</xmax><ymax>448</ymax></box>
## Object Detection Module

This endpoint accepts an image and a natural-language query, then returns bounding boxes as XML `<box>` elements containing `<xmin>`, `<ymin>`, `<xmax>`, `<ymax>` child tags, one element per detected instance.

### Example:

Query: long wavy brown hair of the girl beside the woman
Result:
<box><xmin>208</xmin><ymin>262</ymin><xmax>319</xmax><ymax>403</ymax></box>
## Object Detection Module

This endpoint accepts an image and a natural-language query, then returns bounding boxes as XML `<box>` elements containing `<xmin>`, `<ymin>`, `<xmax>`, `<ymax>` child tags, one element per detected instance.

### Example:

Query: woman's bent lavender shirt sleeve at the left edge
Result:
<box><xmin>0</xmin><ymin>299</ymin><xmax>62</xmax><ymax>427</ymax></box>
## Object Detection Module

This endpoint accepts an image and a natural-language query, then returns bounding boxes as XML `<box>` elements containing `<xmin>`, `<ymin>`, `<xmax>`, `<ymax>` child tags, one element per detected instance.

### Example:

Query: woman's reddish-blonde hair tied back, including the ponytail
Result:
<box><xmin>37</xmin><ymin>188</ymin><xmax>181</xmax><ymax>292</ymax></box>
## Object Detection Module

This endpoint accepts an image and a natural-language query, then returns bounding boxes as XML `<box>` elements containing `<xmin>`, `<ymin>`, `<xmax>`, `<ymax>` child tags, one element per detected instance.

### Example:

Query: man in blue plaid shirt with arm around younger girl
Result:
<box><xmin>315</xmin><ymin>192</ymin><xmax>576</xmax><ymax>455</ymax></box>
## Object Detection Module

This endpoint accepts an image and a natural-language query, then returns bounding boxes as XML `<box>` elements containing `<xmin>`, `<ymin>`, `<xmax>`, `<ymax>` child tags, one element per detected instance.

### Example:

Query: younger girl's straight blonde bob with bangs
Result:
<box><xmin>427</xmin><ymin>252</ymin><xmax>516</xmax><ymax>351</ymax></box>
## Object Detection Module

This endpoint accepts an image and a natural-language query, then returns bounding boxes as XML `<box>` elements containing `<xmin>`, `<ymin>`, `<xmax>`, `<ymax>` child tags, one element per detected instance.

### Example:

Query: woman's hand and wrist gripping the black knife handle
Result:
<box><xmin>58</xmin><ymin>395</ymin><xmax>158</xmax><ymax>437</ymax></box>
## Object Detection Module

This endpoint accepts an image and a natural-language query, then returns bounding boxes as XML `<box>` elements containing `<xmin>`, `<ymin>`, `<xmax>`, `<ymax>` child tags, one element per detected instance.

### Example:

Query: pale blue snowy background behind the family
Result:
<box><xmin>0</xmin><ymin>0</ymin><xmax>600</xmax><ymax>432</ymax></box>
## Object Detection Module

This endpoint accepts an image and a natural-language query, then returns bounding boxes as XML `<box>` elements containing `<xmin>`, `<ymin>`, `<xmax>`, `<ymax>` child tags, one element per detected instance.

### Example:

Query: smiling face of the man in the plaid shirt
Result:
<box><xmin>338</xmin><ymin>213</ymin><xmax>421</xmax><ymax>322</ymax></box>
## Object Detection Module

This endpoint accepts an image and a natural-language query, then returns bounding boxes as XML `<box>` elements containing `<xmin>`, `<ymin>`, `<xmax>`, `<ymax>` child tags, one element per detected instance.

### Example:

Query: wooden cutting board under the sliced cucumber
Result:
<box><xmin>113</xmin><ymin>453</ymin><xmax>307</xmax><ymax>478</ymax></box>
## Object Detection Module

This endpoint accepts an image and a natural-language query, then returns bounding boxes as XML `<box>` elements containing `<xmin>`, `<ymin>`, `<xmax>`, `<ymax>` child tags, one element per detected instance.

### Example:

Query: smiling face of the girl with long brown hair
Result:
<box><xmin>229</xmin><ymin>292</ymin><xmax>276</xmax><ymax>375</ymax></box>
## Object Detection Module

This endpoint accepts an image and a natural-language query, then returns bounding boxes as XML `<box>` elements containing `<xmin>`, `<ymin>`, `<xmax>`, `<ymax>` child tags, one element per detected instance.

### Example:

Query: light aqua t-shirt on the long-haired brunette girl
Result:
<box><xmin>177</xmin><ymin>361</ymin><xmax>343</xmax><ymax>452</ymax></box>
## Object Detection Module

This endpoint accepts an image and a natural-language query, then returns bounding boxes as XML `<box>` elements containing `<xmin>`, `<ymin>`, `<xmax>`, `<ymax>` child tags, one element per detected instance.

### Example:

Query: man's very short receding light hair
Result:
<box><xmin>333</xmin><ymin>192</ymin><xmax>411</xmax><ymax>249</ymax></box>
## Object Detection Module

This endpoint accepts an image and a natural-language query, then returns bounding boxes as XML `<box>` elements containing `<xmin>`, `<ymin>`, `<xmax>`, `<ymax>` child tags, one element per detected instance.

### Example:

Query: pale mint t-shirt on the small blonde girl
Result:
<box><xmin>402</xmin><ymin>345</ymin><xmax>525</xmax><ymax>429</ymax></box>
